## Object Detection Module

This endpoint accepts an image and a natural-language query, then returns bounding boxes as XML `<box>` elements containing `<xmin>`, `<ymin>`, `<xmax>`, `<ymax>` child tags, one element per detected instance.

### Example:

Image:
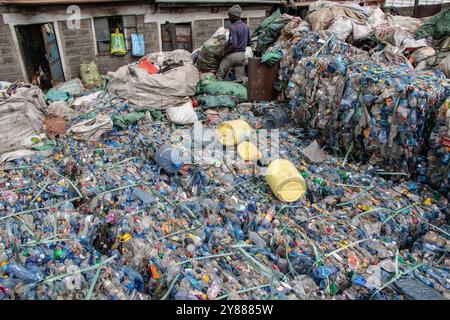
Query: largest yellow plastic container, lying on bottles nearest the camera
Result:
<box><xmin>266</xmin><ymin>159</ymin><xmax>307</xmax><ymax>202</ymax></box>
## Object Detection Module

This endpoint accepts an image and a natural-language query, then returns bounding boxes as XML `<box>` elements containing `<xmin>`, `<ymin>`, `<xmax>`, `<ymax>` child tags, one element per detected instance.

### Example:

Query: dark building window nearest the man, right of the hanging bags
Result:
<box><xmin>161</xmin><ymin>22</ymin><xmax>192</xmax><ymax>52</ymax></box>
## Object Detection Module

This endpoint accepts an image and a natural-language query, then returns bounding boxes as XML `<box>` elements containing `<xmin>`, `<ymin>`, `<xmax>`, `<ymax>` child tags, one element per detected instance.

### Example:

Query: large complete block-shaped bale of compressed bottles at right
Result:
<box><xmin>286</xmin><ymin>50</ymin><xmax>450</xmax><ymax>178</ymax></box>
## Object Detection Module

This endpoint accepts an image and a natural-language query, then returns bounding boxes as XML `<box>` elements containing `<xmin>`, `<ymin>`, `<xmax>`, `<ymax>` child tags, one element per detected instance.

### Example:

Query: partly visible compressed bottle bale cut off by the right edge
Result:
<box><xmin>424</xmin><ymin>99</ymin><xmax>450</xmax><ymax>196</ymax></box>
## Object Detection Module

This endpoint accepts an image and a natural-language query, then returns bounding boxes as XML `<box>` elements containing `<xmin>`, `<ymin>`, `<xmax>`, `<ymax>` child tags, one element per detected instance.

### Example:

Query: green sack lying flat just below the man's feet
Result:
<box><xmin>197</xmin><ymin>77</ymin><xmax>248</xmax><ymax>102</ymax></box>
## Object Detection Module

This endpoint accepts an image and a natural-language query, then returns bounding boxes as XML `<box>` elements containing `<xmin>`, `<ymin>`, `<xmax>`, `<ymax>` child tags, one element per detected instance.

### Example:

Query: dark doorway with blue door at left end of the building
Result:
<box><xmin>16</xmin><ymin>23</ymin><xmax>64</xmax><ymax>90</ymax></box>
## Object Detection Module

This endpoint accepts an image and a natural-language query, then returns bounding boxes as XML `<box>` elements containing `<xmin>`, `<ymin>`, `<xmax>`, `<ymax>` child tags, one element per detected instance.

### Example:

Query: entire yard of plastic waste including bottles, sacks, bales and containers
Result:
<box><xmin>0</xmin><ymin>1</ymin><xmax>450</xmax><ymax>300</ymax></box>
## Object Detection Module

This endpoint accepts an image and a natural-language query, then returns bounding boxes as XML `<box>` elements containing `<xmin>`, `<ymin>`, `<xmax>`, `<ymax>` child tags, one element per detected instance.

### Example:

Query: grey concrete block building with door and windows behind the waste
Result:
<box><xmin>0</xmin><ymin>0</ymin><xmax>283</xmax><ymax>84</ymax></box>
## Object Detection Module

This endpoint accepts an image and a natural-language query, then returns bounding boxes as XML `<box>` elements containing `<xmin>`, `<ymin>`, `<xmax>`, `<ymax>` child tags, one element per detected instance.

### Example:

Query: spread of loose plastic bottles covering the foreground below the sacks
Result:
<box><xmin>0</xmin><ymin>96</ymin><xmax>449</xmax><ymax>300</ymax></box>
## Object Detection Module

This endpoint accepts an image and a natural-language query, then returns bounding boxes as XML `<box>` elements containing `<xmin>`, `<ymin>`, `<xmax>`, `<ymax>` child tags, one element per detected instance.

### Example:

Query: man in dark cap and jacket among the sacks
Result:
<box><xmin>217</xmin><ymin>5</ymin><xmax>251</xmax><ymax>84</ymax></box>
